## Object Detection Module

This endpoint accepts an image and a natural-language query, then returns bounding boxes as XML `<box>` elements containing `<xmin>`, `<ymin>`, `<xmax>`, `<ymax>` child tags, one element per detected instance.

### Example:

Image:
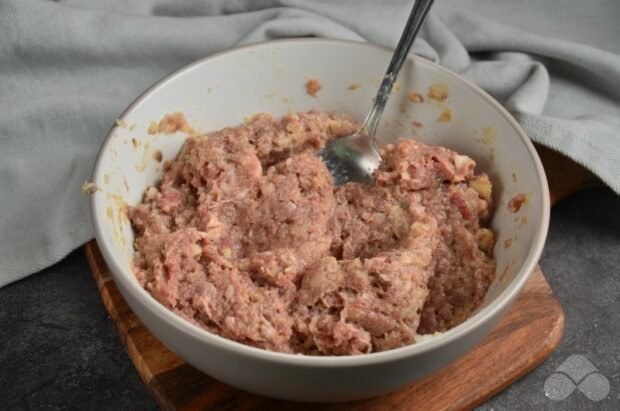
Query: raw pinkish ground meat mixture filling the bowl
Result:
<box><xmin>128</xmin><ymin>111</ymin><xmax>495</xmax><ymax>355</ymax></box>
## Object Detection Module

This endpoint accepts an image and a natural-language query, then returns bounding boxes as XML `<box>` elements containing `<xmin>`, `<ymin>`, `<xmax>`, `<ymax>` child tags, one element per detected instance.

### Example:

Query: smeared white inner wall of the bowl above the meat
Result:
<box><xmin>92</xmin><ymin>39</ymin><xmax>548</xmax><ymax>358</ymax></box>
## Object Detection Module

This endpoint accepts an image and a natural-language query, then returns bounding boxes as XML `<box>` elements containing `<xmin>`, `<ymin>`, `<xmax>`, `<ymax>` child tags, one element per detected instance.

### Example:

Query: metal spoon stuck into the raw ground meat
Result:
<box><xmin>318</xmin><ymin>0</ymin><xmax>434</xmax><ymax>185</ymax></box>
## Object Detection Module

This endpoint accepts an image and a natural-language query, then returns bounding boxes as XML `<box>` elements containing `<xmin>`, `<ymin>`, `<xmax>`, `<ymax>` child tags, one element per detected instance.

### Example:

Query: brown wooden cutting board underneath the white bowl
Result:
<box><xmin>84</xmin><ymin>147</ymin><xmax>600</xmax><ymax>411</ymax></box>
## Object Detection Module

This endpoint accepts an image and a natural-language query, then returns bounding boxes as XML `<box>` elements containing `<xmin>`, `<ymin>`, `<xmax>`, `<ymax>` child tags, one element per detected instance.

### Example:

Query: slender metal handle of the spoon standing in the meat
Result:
<box><xmin>362</xmin><ymin>0</ymin><xmax>434</xmax><ymax>142</ymax></box>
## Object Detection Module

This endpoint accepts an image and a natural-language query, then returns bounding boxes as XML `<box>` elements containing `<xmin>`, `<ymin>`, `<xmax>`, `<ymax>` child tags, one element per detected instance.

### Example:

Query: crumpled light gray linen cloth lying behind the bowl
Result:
<box><xmin>0</xmin><ymin>0</ymin><xmax>620</xmax><ymax>286</ymax></box>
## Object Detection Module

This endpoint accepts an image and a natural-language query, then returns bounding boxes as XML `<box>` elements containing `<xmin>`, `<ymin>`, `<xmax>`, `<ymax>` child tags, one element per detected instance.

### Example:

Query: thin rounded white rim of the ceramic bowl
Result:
<box><xmin>90</xmin><ymin>38</ymin><xmax>550</xmax><ymax>368</ymax></box>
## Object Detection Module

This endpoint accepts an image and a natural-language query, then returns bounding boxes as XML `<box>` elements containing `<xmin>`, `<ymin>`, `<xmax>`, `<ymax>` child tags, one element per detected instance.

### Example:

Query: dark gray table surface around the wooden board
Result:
<box><xmin>0</xmin><ymin>189</ymin><xmax>620</xmax><ymax>410</ymax></box>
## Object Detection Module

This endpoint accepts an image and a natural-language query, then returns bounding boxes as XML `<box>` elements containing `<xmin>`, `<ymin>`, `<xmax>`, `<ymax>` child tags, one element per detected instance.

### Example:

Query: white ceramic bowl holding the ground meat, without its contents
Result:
<box><xmin>91</xmin><ymin>39</ymin><xmax>549</xmax><ymax>401</ymax></box>
